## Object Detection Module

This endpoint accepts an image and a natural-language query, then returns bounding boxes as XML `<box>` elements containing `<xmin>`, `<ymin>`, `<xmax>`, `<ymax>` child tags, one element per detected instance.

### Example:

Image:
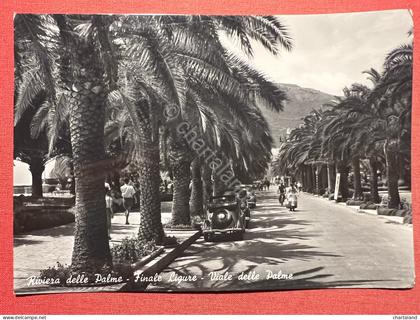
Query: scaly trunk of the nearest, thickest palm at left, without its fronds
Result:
<box><xmin>67</xmin><ymin>39</ymin><xmax>112</xmax><ymax>273</ymax></box>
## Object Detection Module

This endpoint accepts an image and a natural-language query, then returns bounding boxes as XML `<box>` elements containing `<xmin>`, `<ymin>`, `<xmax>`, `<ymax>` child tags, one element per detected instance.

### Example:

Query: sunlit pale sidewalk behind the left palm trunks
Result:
<box><xmin>13</xmin><ymin>202</ymin><xmax>177</xmax><ymax>290</ymax></box>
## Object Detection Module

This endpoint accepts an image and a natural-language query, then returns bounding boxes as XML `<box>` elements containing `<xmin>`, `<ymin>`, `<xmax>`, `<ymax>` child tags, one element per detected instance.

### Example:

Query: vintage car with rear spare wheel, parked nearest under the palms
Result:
<box><xmin>203</xmin><ymin>191</ymin><xmax>245</xmax><ymax>241</ymax></box>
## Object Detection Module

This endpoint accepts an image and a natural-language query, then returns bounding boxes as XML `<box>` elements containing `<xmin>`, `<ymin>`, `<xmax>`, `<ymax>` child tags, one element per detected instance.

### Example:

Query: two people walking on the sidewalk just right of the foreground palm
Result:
<box><xmin>105</xmin><ymin>178</ymin><xmax>138</xmax><ymax>239</ymax></box>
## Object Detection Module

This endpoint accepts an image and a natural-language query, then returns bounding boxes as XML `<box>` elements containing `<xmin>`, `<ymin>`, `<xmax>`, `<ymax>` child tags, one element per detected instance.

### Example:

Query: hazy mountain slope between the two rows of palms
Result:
<box><xmin>261</xmin><ymin>83</ymin><xmax>334</xmax><ymax>148</ymax></box>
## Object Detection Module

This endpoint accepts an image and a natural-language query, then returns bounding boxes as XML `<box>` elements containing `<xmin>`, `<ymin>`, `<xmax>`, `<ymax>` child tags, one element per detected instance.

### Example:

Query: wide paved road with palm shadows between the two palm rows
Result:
<box><xmin>148</xmin><ymin>190</ymin><xmax>414</xmax><ymax>291</ymax></box>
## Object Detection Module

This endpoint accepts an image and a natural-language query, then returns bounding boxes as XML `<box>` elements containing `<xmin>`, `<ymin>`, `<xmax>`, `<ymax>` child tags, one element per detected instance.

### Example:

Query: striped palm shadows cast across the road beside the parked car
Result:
<box><xmin>147</xmin><ymin>192</ymin><xmax>357</xmax><ymax>292</ymax></box>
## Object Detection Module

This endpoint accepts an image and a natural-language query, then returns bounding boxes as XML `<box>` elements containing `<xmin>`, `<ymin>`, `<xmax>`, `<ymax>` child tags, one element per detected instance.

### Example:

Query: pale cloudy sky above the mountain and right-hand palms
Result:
<box><xmin>223</xmin><ymin>10</ymin><xmax>413</xmax><ymax>95</ymax></box>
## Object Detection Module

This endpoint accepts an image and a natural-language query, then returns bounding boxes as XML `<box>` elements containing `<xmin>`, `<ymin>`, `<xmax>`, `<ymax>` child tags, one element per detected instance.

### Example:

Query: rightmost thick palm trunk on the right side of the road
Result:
<box><xmin>385</xmin><ymin>144</ymin><xmax>401</xmax><ymax>209</ymax></box>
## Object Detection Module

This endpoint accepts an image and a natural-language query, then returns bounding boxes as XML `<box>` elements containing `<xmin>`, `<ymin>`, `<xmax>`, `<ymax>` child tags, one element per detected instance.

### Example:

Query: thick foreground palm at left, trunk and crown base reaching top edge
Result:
<box><xmin>54</xmin><ymin>15</ymin><xmax>112</xmax><ymax>272</ymax></box>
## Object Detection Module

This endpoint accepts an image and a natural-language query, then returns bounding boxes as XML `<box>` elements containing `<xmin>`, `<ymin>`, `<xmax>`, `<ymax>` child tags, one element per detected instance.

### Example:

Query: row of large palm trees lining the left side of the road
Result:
<box><xmin>15</xmin><ymin>15</ymin><xmax>292</xmax><ymax>272</ymax></box>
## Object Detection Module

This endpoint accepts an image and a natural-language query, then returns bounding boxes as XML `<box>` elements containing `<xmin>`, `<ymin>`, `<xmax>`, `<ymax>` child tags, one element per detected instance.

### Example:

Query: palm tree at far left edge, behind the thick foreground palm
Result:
<box><xmin>14</xmin><ymin>15</ymin><xmax>54</xmax><ymax>198</ymax></box>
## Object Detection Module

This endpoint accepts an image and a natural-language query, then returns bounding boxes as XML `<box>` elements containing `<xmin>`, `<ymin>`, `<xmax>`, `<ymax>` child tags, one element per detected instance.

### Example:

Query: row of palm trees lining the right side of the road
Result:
<box><xmin>273</xmin><ymin>40</ymin><xmax>413</xmax><ymax>208</ymax></box>
